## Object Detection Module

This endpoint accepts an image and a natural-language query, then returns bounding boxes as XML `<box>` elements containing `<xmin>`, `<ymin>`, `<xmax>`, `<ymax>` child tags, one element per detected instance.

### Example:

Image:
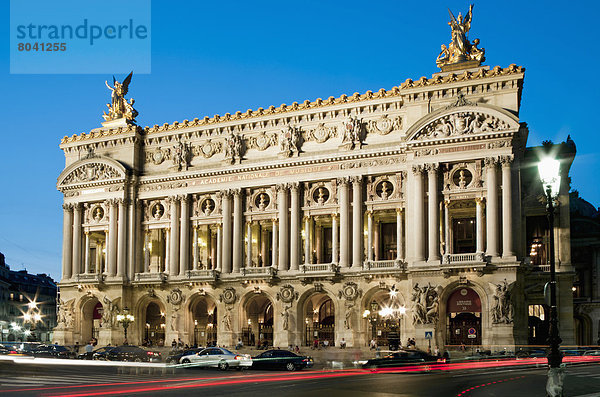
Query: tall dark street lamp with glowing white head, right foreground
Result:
<box><xmin>538</xmin><ymin>157</ymin><xmax>562</xmax><ymax>395</ymax></box>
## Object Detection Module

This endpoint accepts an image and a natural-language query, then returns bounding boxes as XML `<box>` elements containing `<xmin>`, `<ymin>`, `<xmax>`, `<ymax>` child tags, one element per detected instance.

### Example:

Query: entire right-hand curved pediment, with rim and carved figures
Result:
<box><xmin>407</xmin><ymin>105</ymin><xmax>519</xmax><ymax>141</ymax></box>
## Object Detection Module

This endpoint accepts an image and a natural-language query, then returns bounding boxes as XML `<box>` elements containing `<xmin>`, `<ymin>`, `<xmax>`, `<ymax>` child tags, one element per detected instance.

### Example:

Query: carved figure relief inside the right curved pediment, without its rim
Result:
<box><xmin>416</xmin><ymin>112</ymin><xmax>509</xmax><ymax>140</ymax></box>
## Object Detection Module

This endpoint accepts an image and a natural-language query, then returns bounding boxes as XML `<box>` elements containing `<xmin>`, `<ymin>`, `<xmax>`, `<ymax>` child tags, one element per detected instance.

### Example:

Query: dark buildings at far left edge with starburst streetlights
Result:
<box><xmin>0</xmin><ymin>254</ymin><xmax>57</xmax><ymax>342</ymax></box>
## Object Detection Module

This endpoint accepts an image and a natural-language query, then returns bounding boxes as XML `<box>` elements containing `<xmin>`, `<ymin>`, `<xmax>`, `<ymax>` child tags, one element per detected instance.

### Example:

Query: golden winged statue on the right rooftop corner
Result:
<box><xmin>436</xmin><ymin>4</ymin><xmax>485</xmax><ymax>70</ymax></box>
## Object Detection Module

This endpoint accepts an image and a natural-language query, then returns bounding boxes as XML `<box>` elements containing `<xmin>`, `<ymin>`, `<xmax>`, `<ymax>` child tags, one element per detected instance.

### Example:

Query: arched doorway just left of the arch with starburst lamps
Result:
<box><xmin>304</xmin><ymin>293</ymin><xmax>335</xmax><ymax>346</ymax></box>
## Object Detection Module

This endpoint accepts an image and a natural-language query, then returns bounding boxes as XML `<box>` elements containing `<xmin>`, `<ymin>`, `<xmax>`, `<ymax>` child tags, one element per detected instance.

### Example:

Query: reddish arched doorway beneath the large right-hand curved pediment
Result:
<box><xmin>446</xmin><ymin>287</ymin><xmax>481</xmax><ymax>345</ymax></box>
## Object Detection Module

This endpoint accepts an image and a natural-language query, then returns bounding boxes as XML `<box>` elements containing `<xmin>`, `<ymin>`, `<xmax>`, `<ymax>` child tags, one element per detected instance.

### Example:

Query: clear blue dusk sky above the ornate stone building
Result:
<box><xmin>0</xmin><ymin>0</ymin><xmax>600</xmax><ymax>279</ymax></box>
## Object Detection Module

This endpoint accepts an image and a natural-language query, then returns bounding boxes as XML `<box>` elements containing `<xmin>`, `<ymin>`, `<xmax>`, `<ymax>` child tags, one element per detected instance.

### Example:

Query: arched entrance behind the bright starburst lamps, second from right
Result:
<box><xmin>362</xmin><ymin>289</ymin><xmax>406</xmax><ymax>350</ymax></box>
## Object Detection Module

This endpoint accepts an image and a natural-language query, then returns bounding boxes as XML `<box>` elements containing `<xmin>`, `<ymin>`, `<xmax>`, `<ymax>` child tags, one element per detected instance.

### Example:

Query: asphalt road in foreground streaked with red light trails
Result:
<box><xmin>0</xmin><ymin>364</ymin><xmax>600</xmax><ymax>397</ymax></box>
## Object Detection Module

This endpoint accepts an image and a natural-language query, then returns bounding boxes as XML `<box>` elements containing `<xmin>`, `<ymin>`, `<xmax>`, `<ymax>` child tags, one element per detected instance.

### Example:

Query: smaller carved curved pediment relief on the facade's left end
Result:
<box><xmin>58</xmin><ymin>159</ymin><xmax>126</xmax><ymax>187</ymax></box>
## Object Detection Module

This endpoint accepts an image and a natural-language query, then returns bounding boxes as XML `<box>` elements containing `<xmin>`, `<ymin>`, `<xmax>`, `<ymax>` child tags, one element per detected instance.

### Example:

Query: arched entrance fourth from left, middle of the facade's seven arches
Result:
<box><xmin>242</xmin><ymin>294</ymin><xmax>273</xmax><ymax>346</ymax></box>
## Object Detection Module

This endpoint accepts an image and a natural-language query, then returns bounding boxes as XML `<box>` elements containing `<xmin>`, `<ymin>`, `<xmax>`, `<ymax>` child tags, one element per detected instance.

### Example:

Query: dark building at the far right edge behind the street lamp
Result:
<box><xmin>570</xmin><ymin>191</ymin><xmax>600</xmax><ymax>345</ymax></box>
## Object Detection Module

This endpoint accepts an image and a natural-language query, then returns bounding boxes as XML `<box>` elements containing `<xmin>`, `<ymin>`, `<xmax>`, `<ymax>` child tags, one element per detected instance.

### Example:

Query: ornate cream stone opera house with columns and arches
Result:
<box><xmin>55</xmin><ymin>8</ymin><xmax>575</xmax><ymax>349</ymax></box>
